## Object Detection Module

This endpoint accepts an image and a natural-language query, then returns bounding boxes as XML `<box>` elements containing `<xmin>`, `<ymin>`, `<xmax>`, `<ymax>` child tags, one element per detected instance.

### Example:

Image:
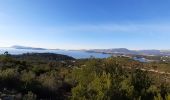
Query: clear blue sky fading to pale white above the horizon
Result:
<box><xmin>0</xmin><ymin>0</ymin><xmax>170</xmax><ymax>49</ymax></box>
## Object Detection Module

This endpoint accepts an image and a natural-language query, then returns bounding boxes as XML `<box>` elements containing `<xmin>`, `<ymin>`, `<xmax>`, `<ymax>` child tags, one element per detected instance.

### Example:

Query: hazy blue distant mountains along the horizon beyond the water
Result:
<box><xmin>8</xmin><ymin>45</ymin><xmax>170</xmax><ymax>56</ymax></box>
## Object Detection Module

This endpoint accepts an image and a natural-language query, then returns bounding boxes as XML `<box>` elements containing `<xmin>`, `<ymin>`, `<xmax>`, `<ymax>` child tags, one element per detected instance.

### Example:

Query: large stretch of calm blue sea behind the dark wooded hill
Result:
<box><xmin>0</xmin><ymin>48</ymin><xmax>111</xmax><ymax>58</ymax></box>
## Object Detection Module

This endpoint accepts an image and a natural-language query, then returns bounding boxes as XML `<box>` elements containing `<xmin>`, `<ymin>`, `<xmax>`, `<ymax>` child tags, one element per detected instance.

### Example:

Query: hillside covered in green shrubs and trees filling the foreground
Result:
<box><xmin>0</xmin><ymin>52</ymin><xmax>170</xmax><ymax>100</ymax></box>
